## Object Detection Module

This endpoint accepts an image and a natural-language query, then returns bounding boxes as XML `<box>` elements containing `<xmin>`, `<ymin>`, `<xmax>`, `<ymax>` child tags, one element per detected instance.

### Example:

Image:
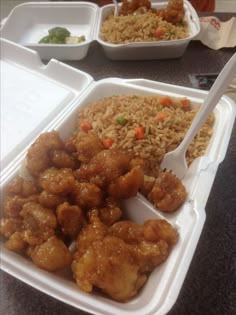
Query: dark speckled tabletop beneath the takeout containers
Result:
<box><xmin>0</xmin><ymin>13</ymin><xmax>236</xmax><ymax>315</ymax></box>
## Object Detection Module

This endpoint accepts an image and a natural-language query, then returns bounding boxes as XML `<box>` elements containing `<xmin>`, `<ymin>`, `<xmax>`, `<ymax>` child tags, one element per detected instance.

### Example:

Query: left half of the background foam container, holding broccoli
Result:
<box><xmin>0</xmin><ymin>2</ymin><xmax>99</xmax><ymax>60</ymax></box>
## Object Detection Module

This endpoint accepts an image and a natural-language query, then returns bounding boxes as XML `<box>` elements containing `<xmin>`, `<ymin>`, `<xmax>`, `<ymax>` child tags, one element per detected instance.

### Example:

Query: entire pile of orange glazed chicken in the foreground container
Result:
<box><xmin>0</xmin><ymin>130</ymin><xmax>183</xmax><ymax>302</ymax></box>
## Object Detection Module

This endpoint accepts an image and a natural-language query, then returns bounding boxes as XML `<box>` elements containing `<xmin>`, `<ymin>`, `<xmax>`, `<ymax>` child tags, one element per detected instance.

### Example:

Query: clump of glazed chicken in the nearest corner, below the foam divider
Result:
<box><xmin>72</xmin><ymin>215</ymin><xmax>178</xmax><ymax>302</ymax></box>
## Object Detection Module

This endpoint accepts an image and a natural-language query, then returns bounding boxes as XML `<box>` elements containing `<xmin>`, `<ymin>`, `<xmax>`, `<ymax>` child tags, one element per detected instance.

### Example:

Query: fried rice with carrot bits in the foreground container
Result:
<box><xmin>78</xmin><ymin>95</ymin><xmax>214</xmax><ymax>175</ymax></box>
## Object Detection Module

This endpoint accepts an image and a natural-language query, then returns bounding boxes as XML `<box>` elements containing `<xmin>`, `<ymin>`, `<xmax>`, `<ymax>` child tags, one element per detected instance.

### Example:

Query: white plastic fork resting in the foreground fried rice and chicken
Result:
<box><xmin>161</xmin><ymin>53</ymin><xmax>236</xmax><ymax>179</ymax></box>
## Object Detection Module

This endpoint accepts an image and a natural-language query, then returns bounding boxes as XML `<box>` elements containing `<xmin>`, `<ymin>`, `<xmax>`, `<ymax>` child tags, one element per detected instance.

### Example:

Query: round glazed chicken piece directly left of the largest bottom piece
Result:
<box><xmin>27</xmin><ymin>235</ymin><xmax>72</xmax><ymax>271</ymax></box>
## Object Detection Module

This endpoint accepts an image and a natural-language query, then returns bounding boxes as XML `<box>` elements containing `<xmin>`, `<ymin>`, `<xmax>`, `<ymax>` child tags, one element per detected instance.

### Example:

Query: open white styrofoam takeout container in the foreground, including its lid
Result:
<box><xmin>0</xmin><ymin>40</ymin><xmax>235</xmax><ymax>315</ymax></box>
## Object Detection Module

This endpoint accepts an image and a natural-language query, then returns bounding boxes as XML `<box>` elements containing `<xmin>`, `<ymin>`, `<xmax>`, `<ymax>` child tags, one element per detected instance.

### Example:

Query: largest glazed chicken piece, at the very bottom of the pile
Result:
<box><xmin>72</xmin><ymin>236</ymin><xmax>147</xmax><ymax>302</ymax></box>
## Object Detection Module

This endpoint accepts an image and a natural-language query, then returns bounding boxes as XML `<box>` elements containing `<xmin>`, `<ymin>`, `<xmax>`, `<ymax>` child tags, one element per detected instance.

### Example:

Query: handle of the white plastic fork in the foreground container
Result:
<box><xmin>176</xmin><ymin>53</ymin><xmax>236</xmax><ymax>152</ymax></box>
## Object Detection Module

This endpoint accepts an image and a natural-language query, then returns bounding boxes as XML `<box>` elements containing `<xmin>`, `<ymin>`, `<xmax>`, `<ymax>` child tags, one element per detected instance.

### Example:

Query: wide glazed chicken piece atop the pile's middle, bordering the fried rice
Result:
<box><xmin>76</xmin><ymin>149</ymin><xmax>130</xmax><ymax>188</ymax></box>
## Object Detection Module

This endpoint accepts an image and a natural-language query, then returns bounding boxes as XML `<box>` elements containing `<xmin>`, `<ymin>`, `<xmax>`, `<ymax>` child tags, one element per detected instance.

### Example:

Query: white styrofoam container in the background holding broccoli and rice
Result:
<box><xmin>0</xmin><ymin>1</ymin><xmax>200</xmax><ymax>60</ymax></box>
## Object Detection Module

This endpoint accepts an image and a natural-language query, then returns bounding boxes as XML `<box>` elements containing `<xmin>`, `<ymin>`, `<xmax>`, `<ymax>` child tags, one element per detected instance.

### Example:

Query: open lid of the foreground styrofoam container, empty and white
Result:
<box><xmin>0</xmin><ymin>39</ymin><xmax>93</xmax><ymax>178</ymax></box>
